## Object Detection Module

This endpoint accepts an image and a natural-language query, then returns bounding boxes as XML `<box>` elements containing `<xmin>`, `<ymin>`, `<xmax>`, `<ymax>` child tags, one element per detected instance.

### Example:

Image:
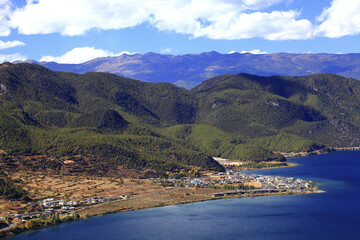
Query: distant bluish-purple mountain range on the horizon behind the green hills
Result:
<box><xmin>23</xmin><ymin>52</ymin><xmax>360</xmax><ymax>89</ymax></box>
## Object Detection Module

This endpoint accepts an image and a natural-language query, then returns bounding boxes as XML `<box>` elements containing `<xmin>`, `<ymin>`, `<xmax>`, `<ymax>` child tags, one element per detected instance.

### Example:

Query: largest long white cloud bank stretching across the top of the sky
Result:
<box><xmin>11</xmin><ymin>0</ymin><xmax>312</xmax><ymax>40</ymax></box>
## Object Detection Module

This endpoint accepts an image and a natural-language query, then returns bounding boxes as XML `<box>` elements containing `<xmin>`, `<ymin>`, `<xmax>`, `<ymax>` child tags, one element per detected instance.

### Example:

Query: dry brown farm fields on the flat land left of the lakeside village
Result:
<box><xmin>0</xmin><ymin>173</ymin><xmax>228</xmax><ymax>216</ymax></box>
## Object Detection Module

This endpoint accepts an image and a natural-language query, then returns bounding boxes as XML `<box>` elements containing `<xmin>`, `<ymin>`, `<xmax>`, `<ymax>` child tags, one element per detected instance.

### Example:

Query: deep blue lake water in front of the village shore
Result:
<box><xmin>9</xmin><ymin>152</ymin><xmax>360</xmax><ymax>240</ymax></box>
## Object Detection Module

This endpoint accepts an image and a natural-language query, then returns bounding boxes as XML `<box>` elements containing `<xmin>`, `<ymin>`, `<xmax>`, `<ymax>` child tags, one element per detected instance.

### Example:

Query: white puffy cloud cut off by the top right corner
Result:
<box><xmin>316</xmin><ymin>0</ymin><xmax>360</xmax><ymax>38</ymax></box>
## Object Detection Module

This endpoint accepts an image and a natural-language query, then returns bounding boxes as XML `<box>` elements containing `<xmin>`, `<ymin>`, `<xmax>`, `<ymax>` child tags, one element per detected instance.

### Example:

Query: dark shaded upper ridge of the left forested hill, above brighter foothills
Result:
<box><xmin>0</xmin><ymin>64</ymin><xmax>197</xmax><ymax>127</ymax></box>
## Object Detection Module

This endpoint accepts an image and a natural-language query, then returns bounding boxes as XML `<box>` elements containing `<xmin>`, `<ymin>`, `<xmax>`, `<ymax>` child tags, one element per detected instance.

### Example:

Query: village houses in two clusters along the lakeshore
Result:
<box><xmin>1</xmin><ymin>170</ymin><xmax>321</xmax><ymax>228</ymax></box>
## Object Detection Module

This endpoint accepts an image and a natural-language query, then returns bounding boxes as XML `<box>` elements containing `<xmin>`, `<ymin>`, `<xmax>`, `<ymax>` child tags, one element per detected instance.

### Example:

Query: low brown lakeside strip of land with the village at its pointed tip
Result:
<box><xmin>0</xmin><ymin>170</ymin><xmax>323</xmax><ymax>237</ymax></box>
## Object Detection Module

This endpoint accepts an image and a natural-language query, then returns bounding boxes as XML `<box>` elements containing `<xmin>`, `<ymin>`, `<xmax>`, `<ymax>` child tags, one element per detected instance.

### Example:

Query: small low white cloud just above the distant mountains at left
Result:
<box><xmin>40</xmin><ymin>47</ymin><xmax>132</xmax><ymax>63</ymax></box>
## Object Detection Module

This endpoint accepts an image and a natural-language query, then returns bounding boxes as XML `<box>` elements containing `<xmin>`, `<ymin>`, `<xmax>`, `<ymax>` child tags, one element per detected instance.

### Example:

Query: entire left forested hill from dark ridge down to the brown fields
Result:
<box><xmin>0</xmin><ymin>64</ymin><xmax>223</xmax><ymax>174</ymax></box>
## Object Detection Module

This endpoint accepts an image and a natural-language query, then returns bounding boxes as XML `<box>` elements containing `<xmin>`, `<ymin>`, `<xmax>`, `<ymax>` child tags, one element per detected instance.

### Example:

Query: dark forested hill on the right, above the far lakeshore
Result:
<box><xmin>191</xmin><ymin>74</ymin><xmax>360</xmax><ymax>147</ymax></box>
